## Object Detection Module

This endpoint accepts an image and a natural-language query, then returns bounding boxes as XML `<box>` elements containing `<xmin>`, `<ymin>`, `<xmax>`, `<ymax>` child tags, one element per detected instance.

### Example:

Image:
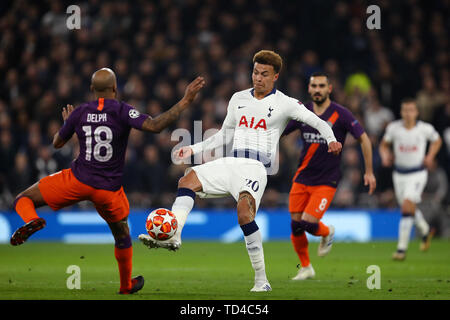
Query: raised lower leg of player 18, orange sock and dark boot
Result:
<box><xmin>10</xmin><ymin>182</ymin><xmax>46</xmax><ymax>246</ymax></box>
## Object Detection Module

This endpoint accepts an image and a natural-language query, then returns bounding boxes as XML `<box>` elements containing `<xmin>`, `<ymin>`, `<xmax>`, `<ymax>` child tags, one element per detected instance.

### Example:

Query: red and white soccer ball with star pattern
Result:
<box><xmin>145</xmin><ymin>208</ymin><xmax>178</xmax><ymax>240</ymax></box>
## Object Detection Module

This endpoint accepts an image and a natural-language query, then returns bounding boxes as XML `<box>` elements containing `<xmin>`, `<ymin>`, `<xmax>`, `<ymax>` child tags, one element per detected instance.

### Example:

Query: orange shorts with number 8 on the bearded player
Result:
<box><xmin>289</xmin><ymin>182</ymin><xmax>336</xmax><ymax>220</ymax></box>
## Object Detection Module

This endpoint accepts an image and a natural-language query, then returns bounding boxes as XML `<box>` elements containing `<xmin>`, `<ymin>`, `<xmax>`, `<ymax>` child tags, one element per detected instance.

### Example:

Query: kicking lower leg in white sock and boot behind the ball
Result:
<box><xmin>139</xmin><ymin>170</ymin><xmax>202</xmax><ymax>251</ymax></box>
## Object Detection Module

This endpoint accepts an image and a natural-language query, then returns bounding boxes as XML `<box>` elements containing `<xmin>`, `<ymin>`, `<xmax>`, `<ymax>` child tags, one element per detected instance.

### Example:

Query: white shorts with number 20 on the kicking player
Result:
<box><xmin>185</xmin><ymin>157</ymin><xmax>267</xmax><ymax>211</ymax></box>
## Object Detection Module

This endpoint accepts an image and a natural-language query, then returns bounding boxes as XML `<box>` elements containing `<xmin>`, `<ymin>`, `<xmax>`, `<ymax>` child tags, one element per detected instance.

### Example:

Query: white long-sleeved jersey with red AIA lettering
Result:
<box><xmin>191</xmin><ymin>89</ymin><xmax>336</xmax><ymax>161</ymax></box>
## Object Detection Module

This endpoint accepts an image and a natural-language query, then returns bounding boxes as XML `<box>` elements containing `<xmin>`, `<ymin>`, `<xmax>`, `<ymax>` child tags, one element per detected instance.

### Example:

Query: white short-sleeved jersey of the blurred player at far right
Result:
<box><xmin>383</xmin><ymin>120</ymin><xmax>439</xmax><ymax>169</ymax></box>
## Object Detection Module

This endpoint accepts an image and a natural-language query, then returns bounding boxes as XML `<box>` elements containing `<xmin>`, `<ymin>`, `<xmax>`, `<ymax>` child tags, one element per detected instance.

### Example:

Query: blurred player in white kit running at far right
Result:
<box><xmin>380</xmin><ymin>98</ymin><xmax>442</xmax><ymax>260</ymax></box>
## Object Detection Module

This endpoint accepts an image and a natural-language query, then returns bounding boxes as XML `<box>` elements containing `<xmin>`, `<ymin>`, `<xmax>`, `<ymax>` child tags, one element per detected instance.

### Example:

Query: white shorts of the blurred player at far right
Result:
<box><xmin>392</xmin><ymin>170</ymin><xmax>428</xmax><ymax>205</ymax></box>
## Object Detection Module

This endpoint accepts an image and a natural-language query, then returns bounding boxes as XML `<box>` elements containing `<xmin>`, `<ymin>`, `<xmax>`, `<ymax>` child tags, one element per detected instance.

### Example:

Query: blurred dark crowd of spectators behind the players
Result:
<box><xmin>0</xmin><ymin>0</ymin><xmax>450</xmax><ymax>235</ymax></box>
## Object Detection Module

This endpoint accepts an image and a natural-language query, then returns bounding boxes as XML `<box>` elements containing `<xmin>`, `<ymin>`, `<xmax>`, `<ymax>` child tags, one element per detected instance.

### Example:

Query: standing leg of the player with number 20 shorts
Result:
<box><xmin>237</xmin><ymin>192</ymin><xmax>272</xmax><ymax>292</ymax></box>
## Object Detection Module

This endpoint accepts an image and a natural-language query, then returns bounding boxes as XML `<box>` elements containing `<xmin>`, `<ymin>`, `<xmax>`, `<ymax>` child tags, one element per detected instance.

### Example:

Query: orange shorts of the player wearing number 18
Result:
<box><xmin>38</xmin><ymin>169</ymin><xmax>130</xmax><ymax>223</ymax></box>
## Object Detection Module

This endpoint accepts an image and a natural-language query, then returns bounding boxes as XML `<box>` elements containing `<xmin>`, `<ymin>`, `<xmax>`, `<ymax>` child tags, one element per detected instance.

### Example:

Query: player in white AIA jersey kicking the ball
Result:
<box><xmin>139</xmin><ymin>50</ymin><xmax>342</xmax><ymax>291</ymax></box>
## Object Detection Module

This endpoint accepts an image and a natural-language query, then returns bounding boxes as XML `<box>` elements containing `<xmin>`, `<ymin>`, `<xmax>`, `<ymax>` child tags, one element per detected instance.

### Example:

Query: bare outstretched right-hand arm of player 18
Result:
<box><xmin>142</xmin><ymin>77</ymin><xmax>205</xmax><ymax>133</ymax></box>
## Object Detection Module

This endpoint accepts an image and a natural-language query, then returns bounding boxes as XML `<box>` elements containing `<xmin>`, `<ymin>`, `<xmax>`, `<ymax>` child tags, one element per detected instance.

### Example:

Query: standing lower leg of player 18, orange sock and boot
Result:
<box><xmin>108</xmin><ymin>218</ymin><xmax>144</xmax><ymax>294</ymax></box>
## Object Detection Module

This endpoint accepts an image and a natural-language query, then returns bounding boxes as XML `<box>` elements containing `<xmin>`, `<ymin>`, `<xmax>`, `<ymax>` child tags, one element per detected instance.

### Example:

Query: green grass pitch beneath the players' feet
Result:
<box><xmin>0</xmin><ymin>239</ymin><xmax>450</xmax><ymax>300</ymax></box>
